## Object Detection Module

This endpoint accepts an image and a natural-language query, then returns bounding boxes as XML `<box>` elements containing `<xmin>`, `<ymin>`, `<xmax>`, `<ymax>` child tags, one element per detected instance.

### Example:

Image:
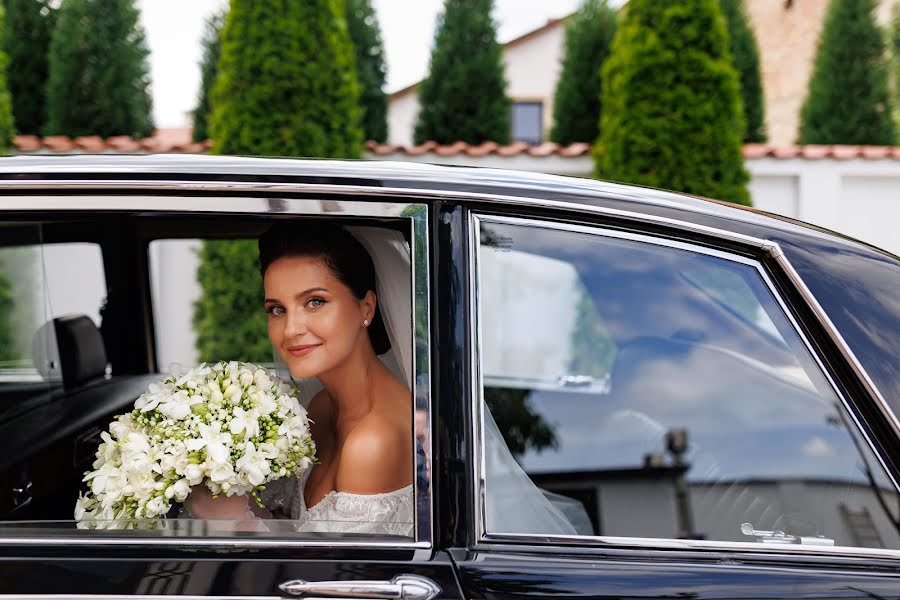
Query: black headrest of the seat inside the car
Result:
<box><xmin>33</xmin><ymin>315</ymin><xmax>106</xmax><ymax>389</ymax></box>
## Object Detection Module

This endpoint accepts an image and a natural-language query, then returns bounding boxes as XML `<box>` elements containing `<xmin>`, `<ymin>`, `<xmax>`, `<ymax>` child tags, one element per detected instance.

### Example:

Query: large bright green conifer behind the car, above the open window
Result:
<box><xmin>210</xmin><ymin>0</ymin><xmax>363</xmax><ymax>158</ymax></box>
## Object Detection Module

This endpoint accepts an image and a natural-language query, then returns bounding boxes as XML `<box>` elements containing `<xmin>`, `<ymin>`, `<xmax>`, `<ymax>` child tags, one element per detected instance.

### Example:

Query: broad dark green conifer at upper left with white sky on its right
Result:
<box><xmin>44</xmin><ymin>0</ymin><xmax>153</xmax><ymax>138</ymax></box>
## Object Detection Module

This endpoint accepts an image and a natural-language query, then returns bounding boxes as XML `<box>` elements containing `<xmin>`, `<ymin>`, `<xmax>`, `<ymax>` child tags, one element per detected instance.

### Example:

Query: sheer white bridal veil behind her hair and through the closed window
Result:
<box><xmin>275</xmin><ymin>226</ymin><xmax>583</xmax><ymax>535</ymax></box>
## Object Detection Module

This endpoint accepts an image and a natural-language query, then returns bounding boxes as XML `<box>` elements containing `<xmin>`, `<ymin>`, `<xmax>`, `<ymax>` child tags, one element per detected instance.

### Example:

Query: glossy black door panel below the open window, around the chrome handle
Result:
<box><xmin>0</xmin><ymin>546</ymin><xmax>460</xmax><ymax>598</ymax></box>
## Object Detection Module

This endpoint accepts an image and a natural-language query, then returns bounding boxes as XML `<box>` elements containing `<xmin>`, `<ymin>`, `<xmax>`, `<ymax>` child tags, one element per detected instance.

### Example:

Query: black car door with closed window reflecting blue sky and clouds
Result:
<box><xmin>452</xmin><ymin>206</ymin><xmax>900</xmax><ymax>598</ymax></box>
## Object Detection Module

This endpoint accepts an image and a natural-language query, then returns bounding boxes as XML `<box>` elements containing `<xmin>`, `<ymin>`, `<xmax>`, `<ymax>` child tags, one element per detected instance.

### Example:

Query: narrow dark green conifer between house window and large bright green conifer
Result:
<box><xmin>550</xmin><ymin>0</ymin><xmax>617</xmax><ymax>145</ymax></box>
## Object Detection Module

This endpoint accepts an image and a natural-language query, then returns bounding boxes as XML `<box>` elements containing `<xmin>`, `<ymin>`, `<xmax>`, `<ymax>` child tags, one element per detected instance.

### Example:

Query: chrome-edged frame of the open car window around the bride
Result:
<box><xmin>0</xmin><ymin>195</ymin><xmax>437</xmax><ymax>550</ymax></box>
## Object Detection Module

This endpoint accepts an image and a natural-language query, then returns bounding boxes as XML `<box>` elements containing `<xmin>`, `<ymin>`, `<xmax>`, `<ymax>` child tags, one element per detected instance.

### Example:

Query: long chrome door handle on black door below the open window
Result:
<box><xmin>278</xmin><ymin>575</ymin><xmax>441</xmax><ymax>600</ymax></box>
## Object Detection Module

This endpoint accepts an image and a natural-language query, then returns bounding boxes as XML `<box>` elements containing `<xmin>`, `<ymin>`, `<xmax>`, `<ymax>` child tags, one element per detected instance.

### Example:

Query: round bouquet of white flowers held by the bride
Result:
<box><xmin>75</xmin><ymin>362</ymin><xmax>315</xmax><ymax>529</ymax></box>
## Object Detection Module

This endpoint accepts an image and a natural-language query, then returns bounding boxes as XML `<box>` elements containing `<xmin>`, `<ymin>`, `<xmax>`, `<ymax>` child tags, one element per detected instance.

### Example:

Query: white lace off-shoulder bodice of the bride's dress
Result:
<box><xmin>262</xmin><ymin>469</ymin><xmax>415</xmax><ymax>537</ymax></box>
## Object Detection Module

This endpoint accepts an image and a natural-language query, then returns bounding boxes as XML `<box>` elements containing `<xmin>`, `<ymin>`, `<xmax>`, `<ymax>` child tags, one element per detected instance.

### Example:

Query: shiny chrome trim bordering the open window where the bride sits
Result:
<box><xmin>0</xmin><ymin>198</ymin><xmax>436</xmax><ymax>549</ymax></box>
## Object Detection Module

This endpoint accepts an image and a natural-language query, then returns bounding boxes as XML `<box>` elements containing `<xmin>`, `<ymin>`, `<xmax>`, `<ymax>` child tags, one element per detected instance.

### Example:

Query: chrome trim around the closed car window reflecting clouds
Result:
<box><xmin>468</xmin><ymin>212</ymin><xmax>900</xmax><ymax>559</ymax></box>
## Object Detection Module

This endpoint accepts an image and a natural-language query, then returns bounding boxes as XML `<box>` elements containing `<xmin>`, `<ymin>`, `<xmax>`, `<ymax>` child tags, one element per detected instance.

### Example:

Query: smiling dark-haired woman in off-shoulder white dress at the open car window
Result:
<box><xmin>186</xmin><ymin>223</ymin><xmax>415</xmax><ymax>537</ymax></box>
